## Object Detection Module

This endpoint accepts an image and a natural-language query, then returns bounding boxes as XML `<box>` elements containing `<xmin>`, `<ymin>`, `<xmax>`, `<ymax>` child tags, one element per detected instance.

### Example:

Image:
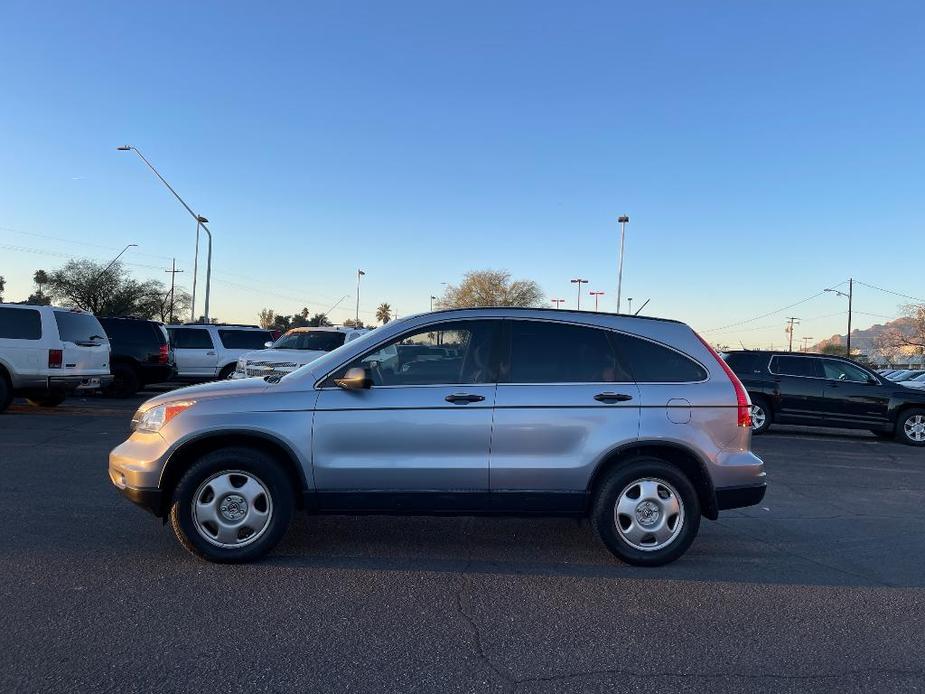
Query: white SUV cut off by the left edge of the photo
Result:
<box><xmin>0</xmin><ymin>304</ymin><xmax>112</xmax><ymax>412</ymax></box>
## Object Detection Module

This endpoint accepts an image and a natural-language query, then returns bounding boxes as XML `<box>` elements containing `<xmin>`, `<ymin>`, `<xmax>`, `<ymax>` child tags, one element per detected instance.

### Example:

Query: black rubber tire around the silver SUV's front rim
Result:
<box><xmin>169</xmin><ymin>447</ymin><xmax>295</xmax><ymax>564</ymax></box>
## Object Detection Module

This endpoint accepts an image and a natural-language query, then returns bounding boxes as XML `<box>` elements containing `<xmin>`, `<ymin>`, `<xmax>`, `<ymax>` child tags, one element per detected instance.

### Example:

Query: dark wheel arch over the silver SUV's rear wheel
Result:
<box><xmin>588</xmin><ymin>440</ymin><xmax>719</xmax><ymax>520</ymax></box>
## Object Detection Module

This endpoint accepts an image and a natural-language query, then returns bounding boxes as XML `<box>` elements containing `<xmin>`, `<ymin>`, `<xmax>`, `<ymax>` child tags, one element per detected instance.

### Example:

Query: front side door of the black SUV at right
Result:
<box><xmin>821</xmin><ymin>359</ymin><xmax>895</xmax><ymax>427</ymax></box>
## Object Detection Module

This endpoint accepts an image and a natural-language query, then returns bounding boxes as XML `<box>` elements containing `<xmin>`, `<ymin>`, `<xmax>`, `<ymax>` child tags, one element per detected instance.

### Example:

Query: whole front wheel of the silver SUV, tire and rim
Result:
<box><xmin>169</xmin><ymin>447</ymin><xmax>294</xmax><ymax>563</ymax></box>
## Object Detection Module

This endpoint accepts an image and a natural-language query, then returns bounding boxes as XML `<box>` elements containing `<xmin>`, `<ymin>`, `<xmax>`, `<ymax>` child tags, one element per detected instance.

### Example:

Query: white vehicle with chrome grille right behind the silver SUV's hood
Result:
<box><xmin>231</xmin><ymin>326</ymin><xmax>369</xmax><ymax>378</ymax></box>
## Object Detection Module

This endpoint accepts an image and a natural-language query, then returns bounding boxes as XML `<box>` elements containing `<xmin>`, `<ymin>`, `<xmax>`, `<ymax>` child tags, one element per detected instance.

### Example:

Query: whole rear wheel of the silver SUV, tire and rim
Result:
<box><xmin>591</xmin><ymin>457</ymin><xmax>700</xmax><ymax>566</ymax></box>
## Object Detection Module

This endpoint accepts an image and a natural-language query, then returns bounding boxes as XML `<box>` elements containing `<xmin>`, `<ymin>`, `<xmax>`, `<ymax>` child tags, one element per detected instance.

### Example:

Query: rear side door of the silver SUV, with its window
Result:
<box><xmin>491</xmin><ymin>320</ymin><xmax>640</xmax><ymax>512</ymax></box>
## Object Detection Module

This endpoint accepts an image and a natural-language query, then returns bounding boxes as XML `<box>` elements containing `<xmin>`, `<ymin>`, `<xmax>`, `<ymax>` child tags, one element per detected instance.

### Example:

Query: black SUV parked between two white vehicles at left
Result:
<box><xmin>98</xmin><ymin>316</ymin><xmax>177</xmax><ymax>398</ymax></box>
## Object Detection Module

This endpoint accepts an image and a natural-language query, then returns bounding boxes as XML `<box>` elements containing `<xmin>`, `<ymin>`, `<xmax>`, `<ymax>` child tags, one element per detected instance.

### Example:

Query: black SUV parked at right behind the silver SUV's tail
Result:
<box><xmin>726</xmin><ymin>350</ymin><xmax>925</xmax><ymax>446</ymax></box>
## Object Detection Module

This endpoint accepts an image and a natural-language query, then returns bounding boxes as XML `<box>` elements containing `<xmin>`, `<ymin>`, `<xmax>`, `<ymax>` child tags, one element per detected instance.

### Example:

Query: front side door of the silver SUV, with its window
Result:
<box><xmin>312</xmin><ymin>320</ymin><xmax>500</xmax><ymax>510</ymax></box>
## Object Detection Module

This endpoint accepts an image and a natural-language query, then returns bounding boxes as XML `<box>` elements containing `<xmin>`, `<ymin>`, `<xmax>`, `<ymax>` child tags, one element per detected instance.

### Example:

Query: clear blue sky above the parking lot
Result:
<box><xmin>0</xmin><ymin>0</ymin><xmax>925</xmax><ymax>345</ymax></box>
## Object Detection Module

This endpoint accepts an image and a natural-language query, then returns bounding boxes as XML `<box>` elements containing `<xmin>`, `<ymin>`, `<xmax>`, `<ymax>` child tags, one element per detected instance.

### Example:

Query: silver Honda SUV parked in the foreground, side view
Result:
<box><xmin>109</xmin><ymin>308</ymin><xmax>765</xmax><ymax>566</ymax></box>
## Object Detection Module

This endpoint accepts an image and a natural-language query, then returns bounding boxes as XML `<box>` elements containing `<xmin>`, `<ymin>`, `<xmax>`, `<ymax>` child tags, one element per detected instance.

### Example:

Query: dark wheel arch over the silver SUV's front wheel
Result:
<box><xmin>158</xmin><ymin>429</ymin><xmax>308</xmax><ymax>515</ymax></box>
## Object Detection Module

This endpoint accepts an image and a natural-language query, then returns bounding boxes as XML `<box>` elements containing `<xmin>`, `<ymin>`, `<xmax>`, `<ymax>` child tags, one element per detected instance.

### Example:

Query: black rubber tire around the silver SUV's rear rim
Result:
<box><xmin>591</xmin><ymin>457</ymin><xmax>700</xmax><ymax>566</ymax></box>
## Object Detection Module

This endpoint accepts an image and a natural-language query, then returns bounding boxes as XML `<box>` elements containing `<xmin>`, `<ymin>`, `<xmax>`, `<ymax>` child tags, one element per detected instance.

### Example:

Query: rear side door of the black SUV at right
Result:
<box><xmin>768</xmin><ymin>354</ymin><xmax>825</xmax><ymax>424</ymax></box>
